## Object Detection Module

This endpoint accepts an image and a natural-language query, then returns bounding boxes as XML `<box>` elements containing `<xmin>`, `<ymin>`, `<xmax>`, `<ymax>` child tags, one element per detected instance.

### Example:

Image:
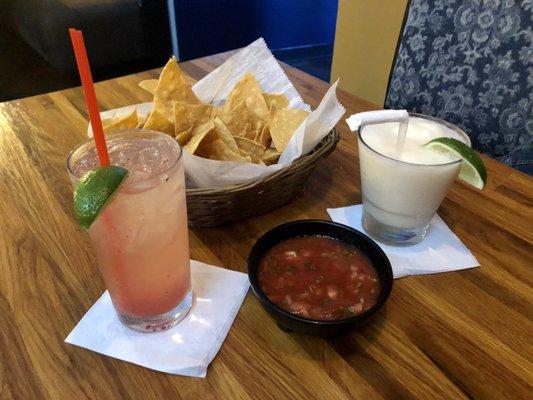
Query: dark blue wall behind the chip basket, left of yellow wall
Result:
<box><xmin>170</xmin><ymin>0</ymin><xmax>337</xmax><ymax>61</ymax></box>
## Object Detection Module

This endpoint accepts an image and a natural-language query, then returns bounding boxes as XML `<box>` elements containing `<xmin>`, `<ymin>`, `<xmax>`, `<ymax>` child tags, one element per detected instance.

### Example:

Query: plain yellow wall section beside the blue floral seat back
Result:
<box><xmin>331</xmin><ymin>0</ymin><xmax>407</xmax><ymax>106</ymax></box>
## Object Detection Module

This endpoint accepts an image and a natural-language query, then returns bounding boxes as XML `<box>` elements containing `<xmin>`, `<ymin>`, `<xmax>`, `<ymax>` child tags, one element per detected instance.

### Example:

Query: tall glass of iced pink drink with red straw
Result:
<box><xmin>67</xmin><ymin>130</ymin><xmax>193</xmax><ymax>332</ymax></box>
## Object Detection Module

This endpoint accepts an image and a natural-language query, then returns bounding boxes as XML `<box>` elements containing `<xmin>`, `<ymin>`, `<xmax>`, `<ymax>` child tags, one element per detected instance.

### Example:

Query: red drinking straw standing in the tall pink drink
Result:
<box><xmin>68</xmin><ymin>28</ymin><xmax>109</xmax><ymax>167</ymax></box>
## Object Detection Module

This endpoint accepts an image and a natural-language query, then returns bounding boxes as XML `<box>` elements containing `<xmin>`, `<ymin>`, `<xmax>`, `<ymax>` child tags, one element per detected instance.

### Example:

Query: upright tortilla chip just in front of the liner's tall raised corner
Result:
<box><xmin>224</xmin><ymin>73</ymin><xmax>268</xmax><ymax>120</ymax></box>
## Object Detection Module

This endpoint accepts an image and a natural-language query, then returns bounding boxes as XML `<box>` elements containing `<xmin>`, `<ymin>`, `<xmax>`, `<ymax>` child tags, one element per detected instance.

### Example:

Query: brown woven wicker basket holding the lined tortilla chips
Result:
<box><xmin>187</xmin><ymin>128</ymin><xmax>339</xmax><ymax>227</ymax></box>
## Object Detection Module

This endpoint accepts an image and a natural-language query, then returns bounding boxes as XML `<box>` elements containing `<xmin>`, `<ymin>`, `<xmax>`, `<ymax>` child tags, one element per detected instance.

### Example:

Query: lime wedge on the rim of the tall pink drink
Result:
<box><xmin>74</xmin><ymin>166</ymin><xmax>128</xmax><ymax>230</ymax></box>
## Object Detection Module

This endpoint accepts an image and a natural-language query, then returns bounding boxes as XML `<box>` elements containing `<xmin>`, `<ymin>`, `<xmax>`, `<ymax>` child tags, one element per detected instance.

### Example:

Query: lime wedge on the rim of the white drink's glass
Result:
<box><xmin>425</xmin><ymin>137</ymin><xmax>487</xmax><ymax>189</ymax></box>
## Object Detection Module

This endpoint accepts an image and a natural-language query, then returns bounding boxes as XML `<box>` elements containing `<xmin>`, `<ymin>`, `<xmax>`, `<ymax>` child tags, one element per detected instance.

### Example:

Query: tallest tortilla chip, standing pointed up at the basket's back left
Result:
<box><xmin>154</xmin><ymin>57</ymin><xmax>201</xmax><ymax>121</ymax></box>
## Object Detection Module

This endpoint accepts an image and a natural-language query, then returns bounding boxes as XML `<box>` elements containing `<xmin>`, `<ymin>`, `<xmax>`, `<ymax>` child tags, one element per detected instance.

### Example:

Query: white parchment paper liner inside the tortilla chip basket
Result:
<box><xmin>88</xmin><ymin>38</ymin><xmax>345</xmax><ymax>188</ymax></box>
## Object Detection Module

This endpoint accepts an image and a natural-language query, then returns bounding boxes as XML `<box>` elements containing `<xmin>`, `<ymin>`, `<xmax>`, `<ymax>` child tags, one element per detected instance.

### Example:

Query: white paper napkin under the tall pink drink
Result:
<box><xmin>65</xmin><ymin>260</ymin><xmax>250</xmax><ymax>378</ymax></box>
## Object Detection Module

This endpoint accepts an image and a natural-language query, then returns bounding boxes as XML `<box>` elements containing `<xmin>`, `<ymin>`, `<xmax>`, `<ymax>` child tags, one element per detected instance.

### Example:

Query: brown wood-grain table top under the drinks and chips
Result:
<box><xmin>0</xmin><ymin>53</ymin><xmax>533</xmax><ymax>400</ymax></box>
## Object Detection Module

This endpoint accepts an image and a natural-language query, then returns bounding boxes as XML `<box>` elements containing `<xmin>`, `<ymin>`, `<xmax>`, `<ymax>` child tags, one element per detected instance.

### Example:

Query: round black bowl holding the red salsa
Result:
<box><xmin>248</xmin><ymin>220</ymin><xmax>393</xmax><ymax>336</ymax></box>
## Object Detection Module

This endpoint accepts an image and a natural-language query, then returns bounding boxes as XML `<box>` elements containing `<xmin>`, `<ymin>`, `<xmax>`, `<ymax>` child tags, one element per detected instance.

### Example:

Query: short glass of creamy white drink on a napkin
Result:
<box><xmin>358</xmin><ymin>114</ymin><xmax>470</xmax><ymax>245</ymax></box>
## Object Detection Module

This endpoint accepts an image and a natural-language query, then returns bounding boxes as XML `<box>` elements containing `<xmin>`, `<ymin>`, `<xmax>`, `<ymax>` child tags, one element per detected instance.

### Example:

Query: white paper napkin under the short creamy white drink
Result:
<box><xmin>327</xmin><ymin>204</ymin><xmax>479</xmax><ymax>278</ymax></box>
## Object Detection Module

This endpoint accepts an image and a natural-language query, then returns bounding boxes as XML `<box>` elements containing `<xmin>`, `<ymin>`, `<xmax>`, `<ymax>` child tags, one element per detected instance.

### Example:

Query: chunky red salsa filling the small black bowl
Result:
<box><xmin>258</xmin><ymin>236</ymin><xmax>380</xmax><ymax>321</ymax></box>
